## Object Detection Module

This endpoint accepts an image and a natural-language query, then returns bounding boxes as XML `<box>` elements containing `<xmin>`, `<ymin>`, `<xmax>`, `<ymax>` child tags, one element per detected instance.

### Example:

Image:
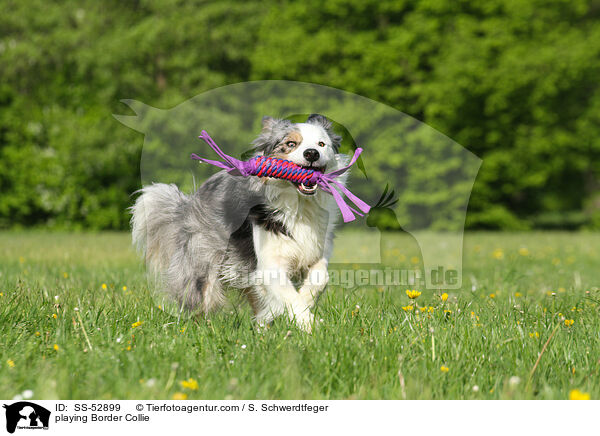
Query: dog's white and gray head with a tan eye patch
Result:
<box><xmin>253</xmin><ymin>114</ymin><xmax>342</xmax><ymax>195</ymax></box>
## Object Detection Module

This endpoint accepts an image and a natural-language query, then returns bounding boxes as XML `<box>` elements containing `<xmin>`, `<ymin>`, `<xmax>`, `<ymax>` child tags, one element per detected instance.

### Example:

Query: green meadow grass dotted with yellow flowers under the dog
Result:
<box><xmin>0</xmin><ymin>232</ymin><xmax>600</xmax><ymax>399</ymax></box>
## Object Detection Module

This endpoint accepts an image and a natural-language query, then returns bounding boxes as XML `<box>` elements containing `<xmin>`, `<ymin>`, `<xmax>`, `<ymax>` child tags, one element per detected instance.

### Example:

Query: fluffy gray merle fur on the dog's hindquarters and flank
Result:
<box><xmin>131</xmin><ymin>175</ymin><xmax>265</xmax><ymax>312</ymax></box>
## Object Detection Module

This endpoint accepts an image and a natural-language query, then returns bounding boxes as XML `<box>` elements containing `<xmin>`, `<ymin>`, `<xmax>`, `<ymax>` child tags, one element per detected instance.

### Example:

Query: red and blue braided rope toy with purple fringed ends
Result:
<box><xmin>191</xmin><ymin>130</ymin><xmax>371</xmax><ymax>223</ymax></box>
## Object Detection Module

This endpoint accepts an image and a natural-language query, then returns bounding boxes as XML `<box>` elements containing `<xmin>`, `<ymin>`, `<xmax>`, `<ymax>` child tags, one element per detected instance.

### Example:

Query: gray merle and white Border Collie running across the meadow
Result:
<box><xmin>131</xmin><ymin>114</ymin><xmax>348</xmax><ymax>332</ymax></box>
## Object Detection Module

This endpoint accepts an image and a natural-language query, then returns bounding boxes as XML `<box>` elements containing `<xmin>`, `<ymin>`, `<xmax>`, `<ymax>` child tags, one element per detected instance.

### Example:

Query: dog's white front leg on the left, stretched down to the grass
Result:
<box><xmin>255</xmin><ymin>264</ymin><xmax>313</xmax><ymax>332</ymax></box>
